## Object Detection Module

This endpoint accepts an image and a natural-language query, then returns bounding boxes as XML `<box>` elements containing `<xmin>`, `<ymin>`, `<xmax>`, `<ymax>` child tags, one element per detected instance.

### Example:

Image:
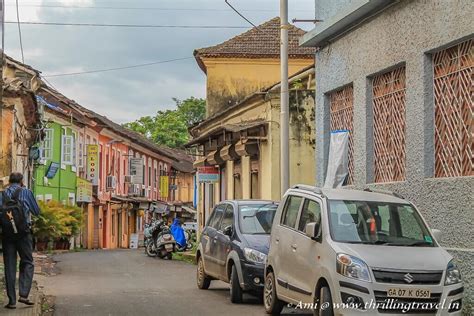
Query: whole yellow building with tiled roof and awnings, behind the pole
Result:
<box><xmin>188</xmin><ymin>18</ymin><xmax>315</xmax><ymax>227</ymax></box>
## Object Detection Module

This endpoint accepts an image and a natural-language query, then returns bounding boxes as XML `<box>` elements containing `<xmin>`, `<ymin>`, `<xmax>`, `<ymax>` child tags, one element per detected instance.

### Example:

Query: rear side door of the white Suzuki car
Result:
<box><xmin>270</xmin><ymin>195</ymin><xmax>303</xmax><ymax>298</ymax></box>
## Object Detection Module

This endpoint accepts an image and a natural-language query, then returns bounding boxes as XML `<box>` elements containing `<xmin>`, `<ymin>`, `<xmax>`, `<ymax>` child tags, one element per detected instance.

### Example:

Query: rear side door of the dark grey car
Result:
<box><xmin>201</xmin><ymin>204</ymin><xmax>226</xmax><ymax>277</ymax></box>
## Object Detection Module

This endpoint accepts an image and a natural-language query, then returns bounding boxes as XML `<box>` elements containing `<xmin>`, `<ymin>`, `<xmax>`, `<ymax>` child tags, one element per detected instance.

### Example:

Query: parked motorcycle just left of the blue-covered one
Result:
<box><xmin>144</xmin><ymin>221</ymin><xmax>176</xmax><ymax>260</ymax></box>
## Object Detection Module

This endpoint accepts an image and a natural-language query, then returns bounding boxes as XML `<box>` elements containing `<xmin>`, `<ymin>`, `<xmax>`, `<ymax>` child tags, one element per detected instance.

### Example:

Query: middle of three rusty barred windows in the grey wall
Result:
<box><xmin>372</xmin><ymin>66</ymin><xmax>406</xmax><ymax>182</ymax></box>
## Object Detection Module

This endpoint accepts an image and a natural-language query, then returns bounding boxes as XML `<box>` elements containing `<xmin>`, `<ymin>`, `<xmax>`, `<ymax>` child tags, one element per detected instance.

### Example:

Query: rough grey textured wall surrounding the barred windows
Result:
<box><xmin>316</xmin><ymin>0</ymin><xmax>474</xmax><ymax>311</ymax></box>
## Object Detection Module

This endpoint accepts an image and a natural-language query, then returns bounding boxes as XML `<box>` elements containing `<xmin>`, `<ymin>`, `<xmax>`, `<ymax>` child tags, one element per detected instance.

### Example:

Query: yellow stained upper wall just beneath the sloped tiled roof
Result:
<box><xmin>203</xmin><ymin>58</ymin><xmax>313</xmax><ymax>116</ymax></box>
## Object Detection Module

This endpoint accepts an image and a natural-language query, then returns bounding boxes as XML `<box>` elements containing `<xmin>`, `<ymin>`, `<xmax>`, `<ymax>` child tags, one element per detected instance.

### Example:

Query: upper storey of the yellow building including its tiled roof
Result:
<box><xmin>194</xmin><ymin>18</ymin><xmax>314</xmax><ymax>117</ymax></box>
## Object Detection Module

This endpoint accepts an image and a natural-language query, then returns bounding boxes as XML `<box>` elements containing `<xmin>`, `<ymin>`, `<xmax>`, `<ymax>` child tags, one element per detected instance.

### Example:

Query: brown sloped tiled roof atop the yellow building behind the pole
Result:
<box><xmin>194</xmin><ymin>17</ymin><xmax>315</xmax><ymax>68</ymax></box>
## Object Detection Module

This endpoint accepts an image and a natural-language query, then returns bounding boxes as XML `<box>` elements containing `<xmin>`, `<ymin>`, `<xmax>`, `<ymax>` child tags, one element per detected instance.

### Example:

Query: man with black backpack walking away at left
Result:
<box><xmin>0</xmin><ymin>172</ymin><xmax>40</xmax><ymax>309</ymax></box>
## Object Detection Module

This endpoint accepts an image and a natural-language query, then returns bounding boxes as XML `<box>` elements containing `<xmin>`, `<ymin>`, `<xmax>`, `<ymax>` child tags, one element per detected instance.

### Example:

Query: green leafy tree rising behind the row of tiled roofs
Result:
<box><xmin>124</xmin><ymin>97</ymin><xmax>206</xmax><ymax>148</ymax></box>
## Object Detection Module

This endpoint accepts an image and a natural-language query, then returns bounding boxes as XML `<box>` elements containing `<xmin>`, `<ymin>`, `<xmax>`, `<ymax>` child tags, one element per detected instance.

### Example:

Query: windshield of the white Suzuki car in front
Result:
<box><xmin>329</xmin><ymin>200</ymin><xmax>434</xmax><ymax>247</ymax></box>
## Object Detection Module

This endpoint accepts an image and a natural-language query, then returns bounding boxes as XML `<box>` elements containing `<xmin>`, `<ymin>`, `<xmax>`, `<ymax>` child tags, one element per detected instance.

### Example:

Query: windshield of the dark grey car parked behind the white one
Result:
<box><xmin>239</xmin><ymin>203</ymin><xmax>278</xmax><ymax>234</ymax></box>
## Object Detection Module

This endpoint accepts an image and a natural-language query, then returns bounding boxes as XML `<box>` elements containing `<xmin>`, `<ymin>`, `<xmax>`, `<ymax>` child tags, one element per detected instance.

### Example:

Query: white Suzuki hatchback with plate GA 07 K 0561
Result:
<box><xmin>264</xmin><ymin>185</ymin><xmax>464</xmax><ymax>316</ymax></box>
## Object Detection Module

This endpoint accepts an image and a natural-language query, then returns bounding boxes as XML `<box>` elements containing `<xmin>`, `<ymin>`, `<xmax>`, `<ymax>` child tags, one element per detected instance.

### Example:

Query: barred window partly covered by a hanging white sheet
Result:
<box><xmin>329</xmin><ymin>85</ymin><xmax>354</xmax><ymax>185</ymax></box>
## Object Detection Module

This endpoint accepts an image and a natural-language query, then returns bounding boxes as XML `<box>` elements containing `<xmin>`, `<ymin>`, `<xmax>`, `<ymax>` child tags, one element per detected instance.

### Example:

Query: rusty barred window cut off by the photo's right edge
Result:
<box><xmin>433</xmin><ymin>40</ymin><xmax>474</xmax><ymax>177</ymax></box>
